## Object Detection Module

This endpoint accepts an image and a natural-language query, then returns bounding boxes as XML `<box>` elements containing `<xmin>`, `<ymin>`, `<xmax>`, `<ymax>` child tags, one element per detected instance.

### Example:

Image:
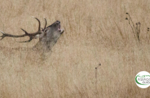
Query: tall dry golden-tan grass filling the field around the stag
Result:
<box><xmin>0</xmin><ymin>0</ymin><xmax>150</xmax><ymax>98</ymax></box>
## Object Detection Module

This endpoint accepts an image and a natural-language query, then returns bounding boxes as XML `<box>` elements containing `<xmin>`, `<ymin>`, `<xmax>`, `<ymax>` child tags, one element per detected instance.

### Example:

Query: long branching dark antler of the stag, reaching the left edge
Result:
<box><xmin>0</xmin><ymin>17</ymin><xmax>42</xmax><ymax>42</ymax></box>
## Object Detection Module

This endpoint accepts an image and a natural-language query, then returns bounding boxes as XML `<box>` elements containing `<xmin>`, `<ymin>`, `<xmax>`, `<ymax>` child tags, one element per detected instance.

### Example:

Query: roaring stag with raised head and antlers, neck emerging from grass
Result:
<box><xmin>0</xmin><ymin>17</ymin><xmax>64</xmax><ymax>52</ymax></box>
